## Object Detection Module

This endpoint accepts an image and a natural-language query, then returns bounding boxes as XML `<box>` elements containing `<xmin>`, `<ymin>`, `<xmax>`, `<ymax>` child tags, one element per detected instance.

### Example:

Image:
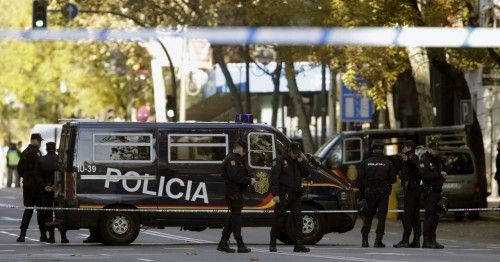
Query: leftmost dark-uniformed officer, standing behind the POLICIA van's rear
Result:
<box><xmin>17</xmin><ymin>133</ymin><xmax>47</xmax><ymax>242</ymax></box>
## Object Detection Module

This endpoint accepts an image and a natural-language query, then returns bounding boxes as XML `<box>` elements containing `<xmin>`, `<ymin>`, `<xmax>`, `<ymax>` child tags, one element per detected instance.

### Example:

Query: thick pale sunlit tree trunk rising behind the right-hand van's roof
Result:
<box><xmin>406</xmin><ymin>47</ymin><xmax>435</xmax><ymax>127</ymax></box>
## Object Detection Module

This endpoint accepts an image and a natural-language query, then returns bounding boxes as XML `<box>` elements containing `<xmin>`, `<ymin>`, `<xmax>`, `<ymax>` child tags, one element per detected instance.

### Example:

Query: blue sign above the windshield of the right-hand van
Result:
<box><xmin>341</xmin><ymin>82</ymin><xmax>375</xmax><ymax>122</ymax></box>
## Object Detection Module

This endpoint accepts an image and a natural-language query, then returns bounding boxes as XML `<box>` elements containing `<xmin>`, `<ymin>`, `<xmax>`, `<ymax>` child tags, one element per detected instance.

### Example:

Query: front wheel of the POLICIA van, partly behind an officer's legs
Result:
<box><xmin>286</xmin><ymin>206</ymin><xmax>326</xmax><ymax>245</ymax></box>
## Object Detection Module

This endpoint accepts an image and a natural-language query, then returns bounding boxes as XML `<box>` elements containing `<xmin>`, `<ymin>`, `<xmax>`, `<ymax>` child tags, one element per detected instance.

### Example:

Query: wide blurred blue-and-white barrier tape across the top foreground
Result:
<box><xmin>0</xmin><ymin>27</ymin><xmax>500</xmax><ymax>48</ymax></box>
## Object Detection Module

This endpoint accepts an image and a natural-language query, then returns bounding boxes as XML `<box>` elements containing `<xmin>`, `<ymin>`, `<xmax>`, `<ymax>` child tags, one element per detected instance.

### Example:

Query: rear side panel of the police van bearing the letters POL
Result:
<box><xmin>76</xmin><ymin>128</ymin><xmax>158</xmax><ymax>219</ymax></box>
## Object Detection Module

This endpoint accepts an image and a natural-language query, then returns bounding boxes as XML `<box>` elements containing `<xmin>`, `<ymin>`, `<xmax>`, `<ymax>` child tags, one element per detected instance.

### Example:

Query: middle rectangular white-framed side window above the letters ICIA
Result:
<box><xmin>168</xmin><ymin>134</ymin><xmax>229</xmax><ymax>164</ymax></box>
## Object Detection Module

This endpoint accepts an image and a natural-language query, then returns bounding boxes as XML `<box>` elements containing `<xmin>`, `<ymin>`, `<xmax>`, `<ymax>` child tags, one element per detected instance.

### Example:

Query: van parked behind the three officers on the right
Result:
<box><xmin>315</xmin><ymin>126</ymin><xmax>488</xmax><ymax>220</ymax></box>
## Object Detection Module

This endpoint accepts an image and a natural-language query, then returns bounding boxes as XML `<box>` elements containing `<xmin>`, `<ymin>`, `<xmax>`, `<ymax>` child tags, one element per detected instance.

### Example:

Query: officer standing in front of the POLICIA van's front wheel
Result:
<box><xmin>269</xmin><ymin>142</ymin><xmax>310</xmax><ymax>252</ymax></box>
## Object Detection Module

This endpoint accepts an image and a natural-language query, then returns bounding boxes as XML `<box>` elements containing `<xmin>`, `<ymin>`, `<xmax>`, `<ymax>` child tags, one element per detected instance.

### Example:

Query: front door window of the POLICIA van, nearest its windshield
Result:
<box><xmin>248</xmin><ymin>133</ymin><xmax>276</xmax><ymax>169</ymax></box>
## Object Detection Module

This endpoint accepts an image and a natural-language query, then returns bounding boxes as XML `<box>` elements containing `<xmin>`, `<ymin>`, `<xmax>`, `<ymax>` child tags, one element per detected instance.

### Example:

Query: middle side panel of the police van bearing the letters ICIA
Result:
<box><xmin>158</xmin><ymin>129</ymin><xmax>231</xmax><ymax>226</ymax></box>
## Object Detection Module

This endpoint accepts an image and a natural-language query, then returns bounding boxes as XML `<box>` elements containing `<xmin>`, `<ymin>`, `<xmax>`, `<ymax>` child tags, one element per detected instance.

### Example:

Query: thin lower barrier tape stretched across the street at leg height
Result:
<box><xmin>0</xmin><ymin>204</ymin><xmax>500</xmax><ymax>214</ymax></box>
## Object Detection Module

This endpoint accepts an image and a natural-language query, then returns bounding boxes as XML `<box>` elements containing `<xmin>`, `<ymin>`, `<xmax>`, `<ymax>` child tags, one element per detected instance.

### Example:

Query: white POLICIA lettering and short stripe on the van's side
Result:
<box><xmin>81</xmin><ymin>167</ymin><xmax>209</xmax><ymax>204</ymax></box>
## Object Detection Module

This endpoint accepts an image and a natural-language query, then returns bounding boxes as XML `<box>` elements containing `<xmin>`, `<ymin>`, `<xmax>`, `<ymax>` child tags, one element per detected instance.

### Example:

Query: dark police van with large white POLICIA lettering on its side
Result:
<box><xmin>55</xmin><ymin>121</ymin><xmax>356</xmax><ymax>245</ymax></box>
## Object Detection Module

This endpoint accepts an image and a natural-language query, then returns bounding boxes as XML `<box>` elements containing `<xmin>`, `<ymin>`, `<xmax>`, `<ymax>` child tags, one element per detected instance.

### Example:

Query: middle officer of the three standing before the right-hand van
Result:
<box><xmin>393</xmin><ymin>140</ymin><xmax>422</xmax><ymax>248</ymax></box>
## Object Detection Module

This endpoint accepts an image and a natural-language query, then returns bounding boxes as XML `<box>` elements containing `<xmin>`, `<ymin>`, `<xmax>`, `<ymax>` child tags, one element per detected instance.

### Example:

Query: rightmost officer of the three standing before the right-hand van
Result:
<box><xmin>420</xmin><ymin>141</ymin><xmax>447</xmax><ymax>249</ymax></box>
